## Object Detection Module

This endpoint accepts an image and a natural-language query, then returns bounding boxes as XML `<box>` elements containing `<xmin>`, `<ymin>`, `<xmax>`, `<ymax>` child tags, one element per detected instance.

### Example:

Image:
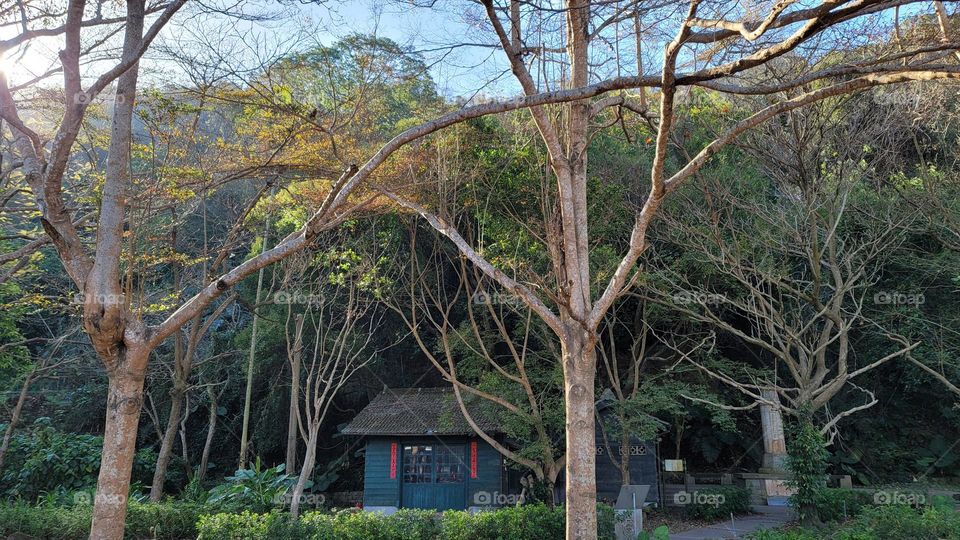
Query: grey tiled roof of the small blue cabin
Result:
<box><xmin>341</xmin><ymin>387</ymin><xmax>503</xmax><ymax>435</ymax></box>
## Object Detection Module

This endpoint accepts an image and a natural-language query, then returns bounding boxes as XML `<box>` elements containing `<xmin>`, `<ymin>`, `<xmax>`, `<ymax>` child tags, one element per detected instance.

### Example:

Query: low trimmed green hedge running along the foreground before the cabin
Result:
<box><xmin>0</xmin><ymin>502</ymin><xmax>616</xmax><ymax>540</ymax></box>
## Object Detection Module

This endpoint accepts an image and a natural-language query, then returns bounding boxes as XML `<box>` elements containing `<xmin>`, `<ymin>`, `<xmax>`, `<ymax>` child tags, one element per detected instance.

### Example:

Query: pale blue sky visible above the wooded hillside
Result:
<box><xmin>0</xmin><ymin>0</ymin><xmax>932</xmax><ymax>102</ymax></box>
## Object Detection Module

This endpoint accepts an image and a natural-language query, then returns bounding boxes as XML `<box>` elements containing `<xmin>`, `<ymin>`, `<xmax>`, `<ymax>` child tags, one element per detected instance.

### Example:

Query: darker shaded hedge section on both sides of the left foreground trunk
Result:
<box><xmin>0</xmin><ymin>503</ymin><xmax>203</xmax><ymax>540</ymax></box>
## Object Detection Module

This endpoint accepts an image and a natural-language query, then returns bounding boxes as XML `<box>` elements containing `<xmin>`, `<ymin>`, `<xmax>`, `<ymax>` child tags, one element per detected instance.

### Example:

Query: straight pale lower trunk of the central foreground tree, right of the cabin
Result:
<box><xmin>562</xmin><ymin>328</ymin><xmax>597</xmax><ymax>540</ymax></box>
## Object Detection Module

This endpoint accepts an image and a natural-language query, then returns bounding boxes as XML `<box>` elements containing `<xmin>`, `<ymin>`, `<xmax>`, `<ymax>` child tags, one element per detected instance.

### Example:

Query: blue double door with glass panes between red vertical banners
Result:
<box><xmin>400</xmin><ymin>443</ymin><xmax>467</xmax><ymax>510</ymax></box>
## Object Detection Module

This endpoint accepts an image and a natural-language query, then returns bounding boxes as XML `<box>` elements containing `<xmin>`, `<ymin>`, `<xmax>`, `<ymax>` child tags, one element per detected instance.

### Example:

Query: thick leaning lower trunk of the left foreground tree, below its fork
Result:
<box><xmin>90</xmin><ymin>348</ymin><xmax>150</xmax><ymax>540</ymax></box>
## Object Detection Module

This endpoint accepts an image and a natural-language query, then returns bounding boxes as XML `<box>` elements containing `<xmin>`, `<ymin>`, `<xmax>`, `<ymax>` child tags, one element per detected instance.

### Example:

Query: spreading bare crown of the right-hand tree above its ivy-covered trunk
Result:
<box><xmin>641</xmin><ymin>168</ymin><xmax>918</xmax><ymax>435</ymax></box>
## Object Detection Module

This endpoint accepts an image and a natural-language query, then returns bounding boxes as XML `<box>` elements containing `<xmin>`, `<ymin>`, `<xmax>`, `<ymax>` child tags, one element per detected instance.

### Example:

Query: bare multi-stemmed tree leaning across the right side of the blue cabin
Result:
<box><xmin>387</xmin><ymin>227</ymin><xmax>565</xmax><ymax>504</ymax></box>
